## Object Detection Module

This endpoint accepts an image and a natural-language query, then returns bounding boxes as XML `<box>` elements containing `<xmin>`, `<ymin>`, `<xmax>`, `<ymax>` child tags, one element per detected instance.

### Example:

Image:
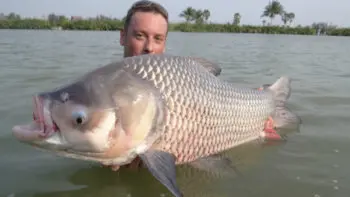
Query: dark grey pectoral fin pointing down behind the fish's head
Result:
<box><xmin>139</xmin><ymin>150</ymin><xmax>183</xmax><ymax>197</ymax></box>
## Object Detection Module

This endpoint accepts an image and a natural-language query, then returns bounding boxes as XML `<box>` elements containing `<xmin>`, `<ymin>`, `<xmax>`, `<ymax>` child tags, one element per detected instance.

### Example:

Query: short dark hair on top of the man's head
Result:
<box><xmin>124</xmin><ymin>0</ymin><xmax>169</xmax><ymax>31</ymax></box>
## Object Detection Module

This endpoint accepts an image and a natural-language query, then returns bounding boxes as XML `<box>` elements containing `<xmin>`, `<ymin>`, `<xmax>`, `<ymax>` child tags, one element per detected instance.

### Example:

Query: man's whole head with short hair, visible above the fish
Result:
<box><xmin>120</xmin><ymin>0</ymin><xmax>168</xmax><ymax>57</ymax></box>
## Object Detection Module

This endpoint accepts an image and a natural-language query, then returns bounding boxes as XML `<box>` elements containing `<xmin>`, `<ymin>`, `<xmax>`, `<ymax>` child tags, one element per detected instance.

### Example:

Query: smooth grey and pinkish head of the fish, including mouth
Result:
<box><xmin>13</xmin><ymin>66</ymin><xmax>163</xmax><ymax>165</ymax></box>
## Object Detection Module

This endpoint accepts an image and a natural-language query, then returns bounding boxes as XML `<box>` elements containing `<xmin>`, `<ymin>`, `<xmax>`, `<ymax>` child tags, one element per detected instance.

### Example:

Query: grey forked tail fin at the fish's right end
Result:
<box><xmin>264</xmin><ymin>76</ymin><xmax>301</xmax><ymax>129</ymax></box>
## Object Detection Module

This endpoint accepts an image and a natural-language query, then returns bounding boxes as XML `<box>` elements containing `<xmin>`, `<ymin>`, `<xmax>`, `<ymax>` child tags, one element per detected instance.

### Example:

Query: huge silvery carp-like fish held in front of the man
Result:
<box><xmin>13</xmin><ymin>54</ymin><xmax>300</xmax><ymax>196</ymax></box>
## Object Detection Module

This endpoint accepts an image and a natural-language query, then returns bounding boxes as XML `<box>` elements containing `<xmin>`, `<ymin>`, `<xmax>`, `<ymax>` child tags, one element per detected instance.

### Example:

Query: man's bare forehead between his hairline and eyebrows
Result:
<box><xmin>129</xmin><ymin>12</ymin><xmax>168</xmax><ymax>34</ymax></box>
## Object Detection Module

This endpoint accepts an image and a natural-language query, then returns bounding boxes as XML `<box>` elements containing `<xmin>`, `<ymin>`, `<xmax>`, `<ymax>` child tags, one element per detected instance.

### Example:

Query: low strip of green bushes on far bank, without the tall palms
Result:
<box><xmin>0</xmin><ymin>19</ymin><xmax>350</xmax><ymax>36</ymax></box>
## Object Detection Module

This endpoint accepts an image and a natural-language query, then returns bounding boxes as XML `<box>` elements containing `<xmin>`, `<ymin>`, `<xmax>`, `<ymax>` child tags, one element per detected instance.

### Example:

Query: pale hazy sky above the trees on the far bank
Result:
<box><xmin>0</xmin><ymin>0</ymin><xmax>350</xmax><ymax>27</ymax></box>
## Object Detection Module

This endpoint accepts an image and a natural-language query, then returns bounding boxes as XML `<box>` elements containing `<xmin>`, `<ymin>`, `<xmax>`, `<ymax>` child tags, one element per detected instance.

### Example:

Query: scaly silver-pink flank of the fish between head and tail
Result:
<box><xmin>124</xmin><ymin>56</ymin><xmax>274</xmax><ymax>163</ymax></box>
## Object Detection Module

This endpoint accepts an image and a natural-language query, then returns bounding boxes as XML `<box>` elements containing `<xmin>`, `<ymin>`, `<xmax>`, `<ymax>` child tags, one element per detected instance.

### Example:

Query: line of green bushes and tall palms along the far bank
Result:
<box><xmin>0</xmin><ymin>0</ymin><xmax>350</xmax><ymax>36</ymax></box>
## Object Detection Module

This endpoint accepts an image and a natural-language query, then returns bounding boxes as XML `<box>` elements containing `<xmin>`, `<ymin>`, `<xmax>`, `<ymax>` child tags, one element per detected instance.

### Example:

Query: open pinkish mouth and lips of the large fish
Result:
<box><xmin>12</xmin><ymin>95</ymin><xmax>59</xmax><ymax>142</ymax></box>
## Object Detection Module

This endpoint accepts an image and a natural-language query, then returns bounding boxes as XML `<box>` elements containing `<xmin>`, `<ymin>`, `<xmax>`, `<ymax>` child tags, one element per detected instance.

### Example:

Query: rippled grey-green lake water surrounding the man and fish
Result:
<box><xmin>0</xmin><ymin>30</ymin><xmax>350</xmax><ymax>197</ymax></box>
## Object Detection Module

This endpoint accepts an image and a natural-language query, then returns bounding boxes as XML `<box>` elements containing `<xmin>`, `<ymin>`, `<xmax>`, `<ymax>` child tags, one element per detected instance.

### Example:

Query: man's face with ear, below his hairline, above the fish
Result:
<box><xmin>120</xmin><ymin>12</ymin><xmax>168</xmax><ymax>57</ymax></box>
